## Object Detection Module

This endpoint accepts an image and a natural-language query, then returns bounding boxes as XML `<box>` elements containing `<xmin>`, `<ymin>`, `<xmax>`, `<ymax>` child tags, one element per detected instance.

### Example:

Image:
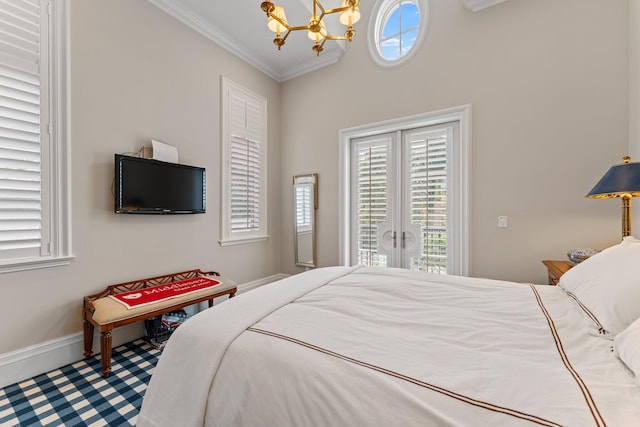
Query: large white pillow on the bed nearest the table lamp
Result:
<box><xmin>558</xmin><ymin>237</ymin><xmax>640</xmax><ymax>335</ymax></box>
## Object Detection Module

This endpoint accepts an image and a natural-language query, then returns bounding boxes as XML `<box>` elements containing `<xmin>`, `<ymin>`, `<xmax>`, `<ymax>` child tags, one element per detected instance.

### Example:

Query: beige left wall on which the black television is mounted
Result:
<box><xmin>0</xmin><ymin>0</ymin><xmax>281</xmax><ymax>358</ymax></box>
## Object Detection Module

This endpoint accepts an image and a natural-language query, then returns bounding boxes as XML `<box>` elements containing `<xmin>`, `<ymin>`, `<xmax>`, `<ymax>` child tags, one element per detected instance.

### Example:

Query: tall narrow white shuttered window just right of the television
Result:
<box><xmin>220</xmin><ymin>78</ymin><xmax>267</xmax><ymax>245</ymax></box>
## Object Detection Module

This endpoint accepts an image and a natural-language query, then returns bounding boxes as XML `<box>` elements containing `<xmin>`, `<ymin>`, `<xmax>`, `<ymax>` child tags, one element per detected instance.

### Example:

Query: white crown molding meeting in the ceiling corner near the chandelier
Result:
<box><xmin>147</xmin><ymin>0</ymin><xmax>344</xmax><ymax>83</ymax></box>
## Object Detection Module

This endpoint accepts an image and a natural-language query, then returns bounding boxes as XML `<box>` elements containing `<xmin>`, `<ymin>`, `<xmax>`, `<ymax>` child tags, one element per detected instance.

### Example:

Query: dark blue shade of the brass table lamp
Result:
<box><xmin>587</xmin><ymin>157</ymin><xmax>640</xmax><ymax>199</ymax></box>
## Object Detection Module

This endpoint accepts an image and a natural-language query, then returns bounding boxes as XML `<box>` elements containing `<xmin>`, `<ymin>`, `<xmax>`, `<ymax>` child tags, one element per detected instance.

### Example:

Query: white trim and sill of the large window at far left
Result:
<box><xmin>0</xmin><ymin>0</ymin><xmax>74</xmax><ymax>273</ymax></box>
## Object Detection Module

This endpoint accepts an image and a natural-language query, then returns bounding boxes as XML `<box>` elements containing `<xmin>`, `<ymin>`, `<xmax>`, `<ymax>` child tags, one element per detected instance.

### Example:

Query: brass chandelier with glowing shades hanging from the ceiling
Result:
<box><xmin>260</xmin><ymin>0</ymin><xmax>360</xmax><ymax>56</ymax></box>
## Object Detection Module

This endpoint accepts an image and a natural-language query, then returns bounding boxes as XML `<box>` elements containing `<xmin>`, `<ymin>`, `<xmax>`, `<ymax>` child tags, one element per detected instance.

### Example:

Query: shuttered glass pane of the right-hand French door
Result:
<box><xmin>405</xmin><ymin>129</ymin><xmax>450</xmax><ymax>274</ymax></box>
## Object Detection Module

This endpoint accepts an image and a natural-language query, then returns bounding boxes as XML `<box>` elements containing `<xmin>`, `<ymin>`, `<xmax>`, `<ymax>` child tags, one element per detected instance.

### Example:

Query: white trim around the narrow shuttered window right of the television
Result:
<box><xmin>218</xmin><ymin>77</ymin><xmax>269</xmax><ymax>246</ymax></box>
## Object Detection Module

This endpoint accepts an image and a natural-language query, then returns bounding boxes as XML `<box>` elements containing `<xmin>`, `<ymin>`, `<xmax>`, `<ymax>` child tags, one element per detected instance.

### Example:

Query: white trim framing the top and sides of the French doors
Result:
<box><xmin>338</xmin><ymin>104</ymin><xmax>471</xmax><ymax>276</ymax></box>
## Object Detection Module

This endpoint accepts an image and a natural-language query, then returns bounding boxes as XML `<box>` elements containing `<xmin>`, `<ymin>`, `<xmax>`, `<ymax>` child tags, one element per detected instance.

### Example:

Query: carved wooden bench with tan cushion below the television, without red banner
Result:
<box><xmin>82</xmin><ymin>269</ymin><xmax>237</xmax><ymax>378</ymax></box>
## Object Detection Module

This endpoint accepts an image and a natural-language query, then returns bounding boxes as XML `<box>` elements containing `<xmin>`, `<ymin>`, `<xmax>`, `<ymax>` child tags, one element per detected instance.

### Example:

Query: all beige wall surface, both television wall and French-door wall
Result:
<box><xmin>0</xmin><ymin>0</ymin><xmax>637</xmax><ymax>354</ymax></box>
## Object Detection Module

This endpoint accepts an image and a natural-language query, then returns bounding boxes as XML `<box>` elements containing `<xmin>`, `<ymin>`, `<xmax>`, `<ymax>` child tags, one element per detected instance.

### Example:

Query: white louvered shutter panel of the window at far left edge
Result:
<box><xmin>0</xmin><ymin>0</ymin><xmax>47</xmax><ymax>258</ymax></box>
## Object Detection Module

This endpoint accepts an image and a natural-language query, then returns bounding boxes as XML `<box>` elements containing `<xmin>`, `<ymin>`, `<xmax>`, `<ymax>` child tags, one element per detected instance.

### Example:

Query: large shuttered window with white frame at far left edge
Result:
<box><xmin>0</xmin><ymin>0</ymin><xmax>69</xmax><ymax>271</ymax></box>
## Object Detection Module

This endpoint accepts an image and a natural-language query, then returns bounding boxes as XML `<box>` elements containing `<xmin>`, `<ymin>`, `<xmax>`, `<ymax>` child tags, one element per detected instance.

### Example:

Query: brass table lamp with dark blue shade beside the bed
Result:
<box><xmin>587</xmin><ymin>156</ymin><xmax>640</xmax><ymax>239</ymax></box>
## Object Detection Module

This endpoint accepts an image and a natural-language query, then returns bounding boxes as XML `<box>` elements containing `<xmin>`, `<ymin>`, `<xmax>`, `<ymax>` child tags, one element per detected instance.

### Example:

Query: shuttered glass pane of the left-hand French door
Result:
<box><xmin>353</xmin><ymin>140</ymin><xmax>391</xmax><ymax>267</ymax></box>
